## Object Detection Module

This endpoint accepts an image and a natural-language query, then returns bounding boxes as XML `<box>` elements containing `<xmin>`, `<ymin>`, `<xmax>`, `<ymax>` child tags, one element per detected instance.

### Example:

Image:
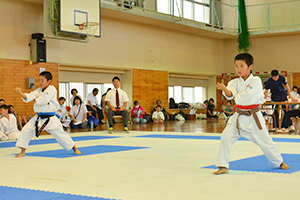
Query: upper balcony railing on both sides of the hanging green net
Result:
<box><xmin>102</xmin><ymin>0</ymin><xmax>300</xmax><ymax>34</ymax></box>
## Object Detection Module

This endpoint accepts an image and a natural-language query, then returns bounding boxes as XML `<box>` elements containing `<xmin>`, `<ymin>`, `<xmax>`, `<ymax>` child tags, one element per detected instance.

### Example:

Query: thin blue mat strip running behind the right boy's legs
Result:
<box><xmin>134</xmin><ymin>134</ymin><xmax>300</xmax><ymax>143</ymax></box>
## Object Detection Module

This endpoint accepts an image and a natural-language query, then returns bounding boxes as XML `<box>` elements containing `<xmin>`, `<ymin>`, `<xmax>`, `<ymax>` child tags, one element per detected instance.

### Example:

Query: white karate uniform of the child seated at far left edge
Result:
<box><xmin>0</xmin><ymin>114</ymin><xmax>21</xmax><ymax>140</ymax></box>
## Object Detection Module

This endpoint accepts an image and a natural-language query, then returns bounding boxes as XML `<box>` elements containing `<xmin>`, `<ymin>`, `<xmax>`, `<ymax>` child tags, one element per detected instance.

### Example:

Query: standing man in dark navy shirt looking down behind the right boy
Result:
<box><xmin>265</xmin><ymin>69</ymin><xmax>293</xmax><ymax>132</ymax></box>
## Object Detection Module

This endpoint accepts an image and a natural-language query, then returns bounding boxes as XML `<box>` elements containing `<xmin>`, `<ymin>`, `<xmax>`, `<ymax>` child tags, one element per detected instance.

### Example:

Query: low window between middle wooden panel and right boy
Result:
<box><xmin>169</xmin><ymin>86</ymin><xmax>206</xmax><ymax>103</ymax></box>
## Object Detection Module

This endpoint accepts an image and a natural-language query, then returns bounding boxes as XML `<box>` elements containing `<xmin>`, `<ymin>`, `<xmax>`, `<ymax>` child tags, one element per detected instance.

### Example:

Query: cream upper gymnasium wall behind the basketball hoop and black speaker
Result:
<box><xmin>0</xmin><ymin>0</ymin><xmax>223</xmax><ymax>75</ymax></box>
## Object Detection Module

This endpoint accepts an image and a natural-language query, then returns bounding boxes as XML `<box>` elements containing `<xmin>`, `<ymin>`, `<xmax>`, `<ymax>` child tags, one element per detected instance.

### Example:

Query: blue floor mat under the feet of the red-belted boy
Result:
<box><xmin>203</xmin><ymin>154</ymin><xmax>300</xmax><ymax>174</ymax></box>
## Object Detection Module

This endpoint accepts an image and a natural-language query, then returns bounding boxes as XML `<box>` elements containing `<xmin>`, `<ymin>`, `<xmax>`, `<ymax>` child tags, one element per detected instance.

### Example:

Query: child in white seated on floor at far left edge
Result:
<box><xmin>0</xmin><ymin>104</ymin><xmax>21</xmax><ymax>141</ymax></box>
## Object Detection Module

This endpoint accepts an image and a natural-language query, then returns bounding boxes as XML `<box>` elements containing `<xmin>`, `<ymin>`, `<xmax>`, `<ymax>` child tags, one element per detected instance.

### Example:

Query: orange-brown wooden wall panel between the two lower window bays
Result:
<box><xmin>132</xmin><ymin>69</ymin><xmax>169</xmax><ymax>113</ymax></box>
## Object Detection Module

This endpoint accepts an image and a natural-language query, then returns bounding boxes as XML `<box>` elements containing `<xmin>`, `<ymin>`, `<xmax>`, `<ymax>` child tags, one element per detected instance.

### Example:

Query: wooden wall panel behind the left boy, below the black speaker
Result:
<box><xmin>0</xmin><ymin>59</ymin><xmax>59</xmax><ymax>118</ymax></box>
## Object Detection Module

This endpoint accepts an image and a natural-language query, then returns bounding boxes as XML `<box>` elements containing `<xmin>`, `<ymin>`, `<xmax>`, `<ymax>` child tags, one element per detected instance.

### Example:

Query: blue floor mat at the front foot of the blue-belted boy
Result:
<box><xmin>26</xmin><ymin>145</ymin><xmax>148</xmax><ymax>158</ymax></box>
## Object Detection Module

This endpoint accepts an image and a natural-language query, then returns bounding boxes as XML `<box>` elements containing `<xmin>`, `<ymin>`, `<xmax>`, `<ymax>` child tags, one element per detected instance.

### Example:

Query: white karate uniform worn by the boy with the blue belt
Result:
<box><xmin>16</xmin><ymin>85</ymin><xmax>75</xmax><ymax>151</ymax></box>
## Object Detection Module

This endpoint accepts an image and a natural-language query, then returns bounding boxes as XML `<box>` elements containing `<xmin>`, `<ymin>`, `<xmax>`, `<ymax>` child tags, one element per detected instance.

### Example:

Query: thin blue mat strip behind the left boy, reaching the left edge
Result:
<box><xmin>0</xmin><ymin>135</ymin><xmax>119</xmax><ymax>148</ymax></box>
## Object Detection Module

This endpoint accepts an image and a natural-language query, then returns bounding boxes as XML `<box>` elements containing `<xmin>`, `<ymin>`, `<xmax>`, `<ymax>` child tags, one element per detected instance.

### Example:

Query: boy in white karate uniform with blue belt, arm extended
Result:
<box><xmin>15</xmin><ymin>71</ymin><xmax>81</xmax><ymax>157</ymax></box>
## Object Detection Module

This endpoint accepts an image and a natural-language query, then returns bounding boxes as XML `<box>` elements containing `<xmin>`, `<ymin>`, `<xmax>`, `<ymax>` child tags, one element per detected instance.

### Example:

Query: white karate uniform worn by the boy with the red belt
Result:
<box><xmin>216</xmin><ymin>74</ymin><xmax>283</xmax><ymax>168</ymax></box>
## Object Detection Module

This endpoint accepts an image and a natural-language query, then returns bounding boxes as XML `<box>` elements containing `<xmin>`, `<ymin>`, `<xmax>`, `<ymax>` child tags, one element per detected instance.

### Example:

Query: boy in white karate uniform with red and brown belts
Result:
<box><xmin>214</xmin><ymin>53</ymin><xmax>289</xmax><ymax>175</ymax></box>
